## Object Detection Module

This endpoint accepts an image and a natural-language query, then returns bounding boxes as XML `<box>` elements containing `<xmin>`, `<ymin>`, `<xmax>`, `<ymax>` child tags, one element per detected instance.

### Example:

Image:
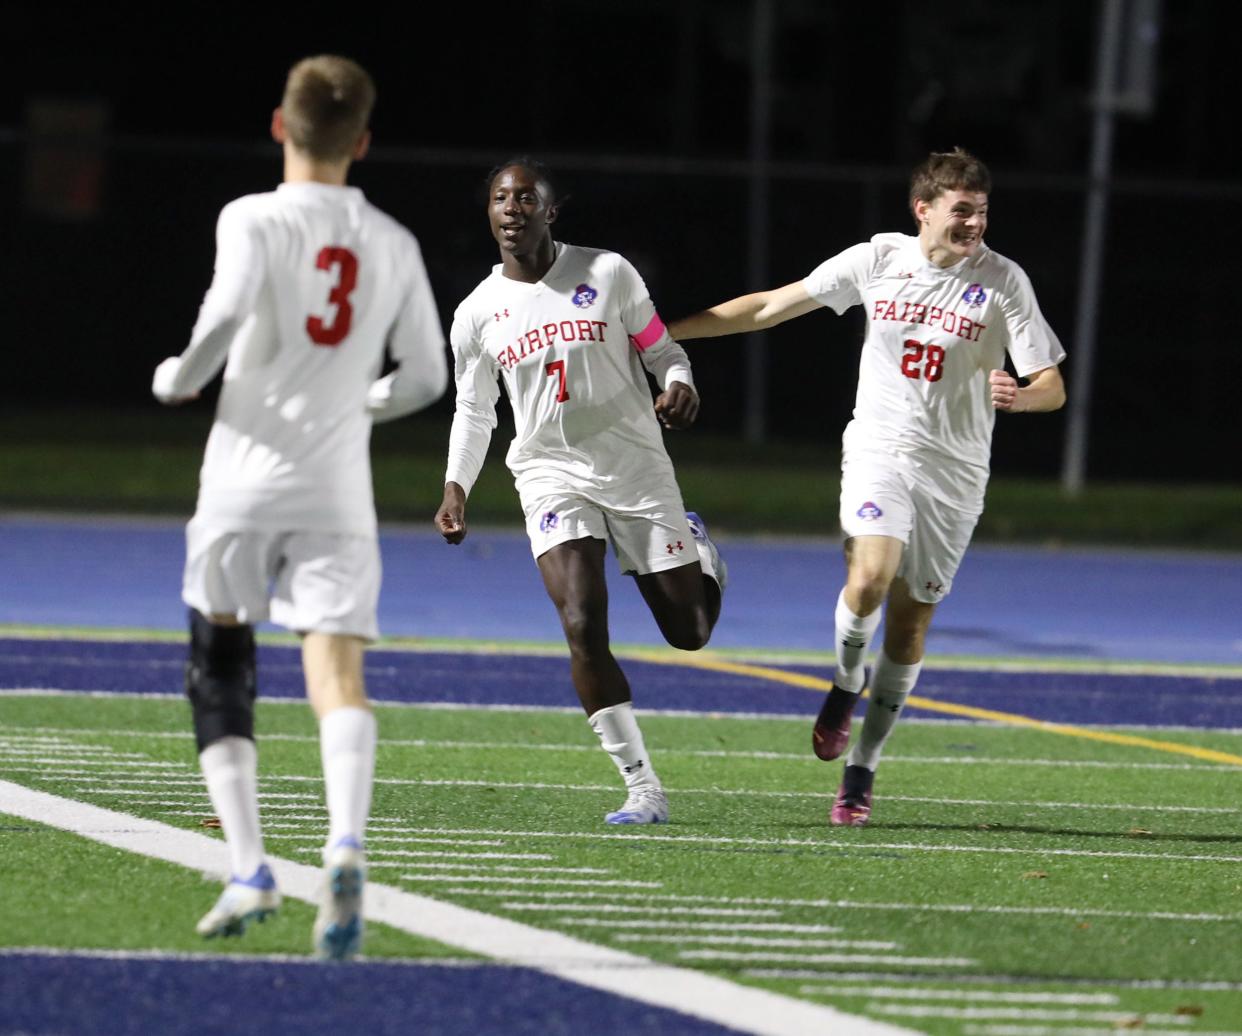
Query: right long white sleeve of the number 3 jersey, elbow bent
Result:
<box><xmin>366</xmin><ymin>240</ymin><xmax>448</xmax><ymax>421</ymax></box>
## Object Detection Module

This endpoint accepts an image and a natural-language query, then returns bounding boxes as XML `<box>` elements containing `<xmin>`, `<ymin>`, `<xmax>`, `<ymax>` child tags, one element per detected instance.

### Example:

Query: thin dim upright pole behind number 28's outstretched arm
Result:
<box><xmin>744</xmin><ymin>0</ymin><xmax>775</xmax><ymax>443</ymax></box>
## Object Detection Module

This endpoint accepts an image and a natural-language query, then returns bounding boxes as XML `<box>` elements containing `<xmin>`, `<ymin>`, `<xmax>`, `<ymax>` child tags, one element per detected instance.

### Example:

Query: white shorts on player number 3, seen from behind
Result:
<box><xmin>181</xmin><ymin>520</ymin><xmax>381</xmax><ymax>641</ymax></box>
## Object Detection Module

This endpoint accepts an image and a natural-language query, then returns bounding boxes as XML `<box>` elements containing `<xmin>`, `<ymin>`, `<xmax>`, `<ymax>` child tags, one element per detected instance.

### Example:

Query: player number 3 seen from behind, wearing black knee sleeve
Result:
<box><xmin>152</xmin><ymin>55</ymin><xmax>448</xmax><ymax>959</ymax></box>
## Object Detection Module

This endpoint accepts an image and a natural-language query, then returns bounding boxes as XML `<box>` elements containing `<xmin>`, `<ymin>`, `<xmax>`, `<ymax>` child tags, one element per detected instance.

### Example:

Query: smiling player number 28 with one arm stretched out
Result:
<box><xmin>669</xmin><ymin>148</ymin><xmax>1066</xmax><ymax>827</ymax></box>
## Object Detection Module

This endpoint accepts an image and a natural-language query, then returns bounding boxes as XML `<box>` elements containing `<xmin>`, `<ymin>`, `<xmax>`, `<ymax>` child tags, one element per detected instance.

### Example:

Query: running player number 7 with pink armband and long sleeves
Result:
<box><xmin>435</xmin><ymin>158</ymin><xmax>727</xmax><ymax>824</ymax></box>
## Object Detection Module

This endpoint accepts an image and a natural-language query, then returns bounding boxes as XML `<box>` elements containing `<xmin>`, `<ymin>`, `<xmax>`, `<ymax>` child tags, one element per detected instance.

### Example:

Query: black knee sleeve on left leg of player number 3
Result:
<box><xmin>185</xmin><ymin>611</ymin><xmax>255</xmax><ymax>752</ymax></box>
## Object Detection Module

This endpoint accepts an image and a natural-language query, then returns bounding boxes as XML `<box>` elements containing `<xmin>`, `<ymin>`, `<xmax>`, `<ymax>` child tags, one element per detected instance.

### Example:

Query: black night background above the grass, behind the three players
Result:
<box><xmin>0</xmin><ymin>0</ymin><xmax>1242</xmax><ymax>482</ymax></box>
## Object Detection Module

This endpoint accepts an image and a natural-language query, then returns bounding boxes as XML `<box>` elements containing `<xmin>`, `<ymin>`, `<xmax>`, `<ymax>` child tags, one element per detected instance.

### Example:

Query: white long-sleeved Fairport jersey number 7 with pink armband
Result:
<box><xmin>445</xmin><ymin>243</ymin><xmax>694</xmax><ymax>501</ymax></box>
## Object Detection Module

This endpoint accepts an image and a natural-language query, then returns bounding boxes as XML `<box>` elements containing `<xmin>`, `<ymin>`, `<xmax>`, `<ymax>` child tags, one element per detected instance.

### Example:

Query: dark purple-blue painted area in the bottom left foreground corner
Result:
<box><xmin>0</xmin><ymin>952</ymin><xmax>735</xmax><ymax>1036</ymax></box>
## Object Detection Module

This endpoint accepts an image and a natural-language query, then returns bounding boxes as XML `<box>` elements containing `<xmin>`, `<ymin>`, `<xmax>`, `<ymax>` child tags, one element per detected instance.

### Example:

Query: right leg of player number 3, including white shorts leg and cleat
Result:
<box><xmin>272</xmin><ymin>533</ymin><xmax>380</xmax><ymax>960</ymax></box>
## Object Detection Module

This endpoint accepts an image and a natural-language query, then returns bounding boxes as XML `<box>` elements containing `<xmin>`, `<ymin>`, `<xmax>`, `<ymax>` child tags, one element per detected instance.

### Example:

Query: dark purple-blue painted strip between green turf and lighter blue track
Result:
<box><xmin>0</xmin><ymin>638</ymin><xmax>1242</xmax><ymax>728</ymax></box>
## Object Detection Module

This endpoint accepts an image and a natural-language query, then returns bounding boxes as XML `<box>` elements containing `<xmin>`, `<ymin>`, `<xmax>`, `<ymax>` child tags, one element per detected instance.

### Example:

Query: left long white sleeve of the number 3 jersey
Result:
<box><xmin>152</xmin><ymin>201</ymin><xmax>267</xmax><ymax>401</ymax></box>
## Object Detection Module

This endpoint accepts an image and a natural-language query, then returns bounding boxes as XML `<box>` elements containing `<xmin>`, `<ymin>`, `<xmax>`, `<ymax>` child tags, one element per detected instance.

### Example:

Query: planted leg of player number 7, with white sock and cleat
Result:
<box><xmin>538</xmin><ymin>537</ymin><xmax>668</xmax><ymax>824</ymax></box>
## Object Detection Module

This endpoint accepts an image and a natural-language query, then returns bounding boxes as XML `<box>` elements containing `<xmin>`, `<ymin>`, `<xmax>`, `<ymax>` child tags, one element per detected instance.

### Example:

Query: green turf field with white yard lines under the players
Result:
<box><xmin>0</xmin><ymin>696</ymin><xmax>1242</xmax><ymax>1036</ymax></box>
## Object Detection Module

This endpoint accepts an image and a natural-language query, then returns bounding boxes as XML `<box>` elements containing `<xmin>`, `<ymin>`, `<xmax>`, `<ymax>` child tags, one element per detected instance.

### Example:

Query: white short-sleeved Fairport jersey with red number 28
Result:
<box><xmin>802</xmin><ymin>234</ymin><xmax>1066</xmax><ymax>477</ymax></box>
